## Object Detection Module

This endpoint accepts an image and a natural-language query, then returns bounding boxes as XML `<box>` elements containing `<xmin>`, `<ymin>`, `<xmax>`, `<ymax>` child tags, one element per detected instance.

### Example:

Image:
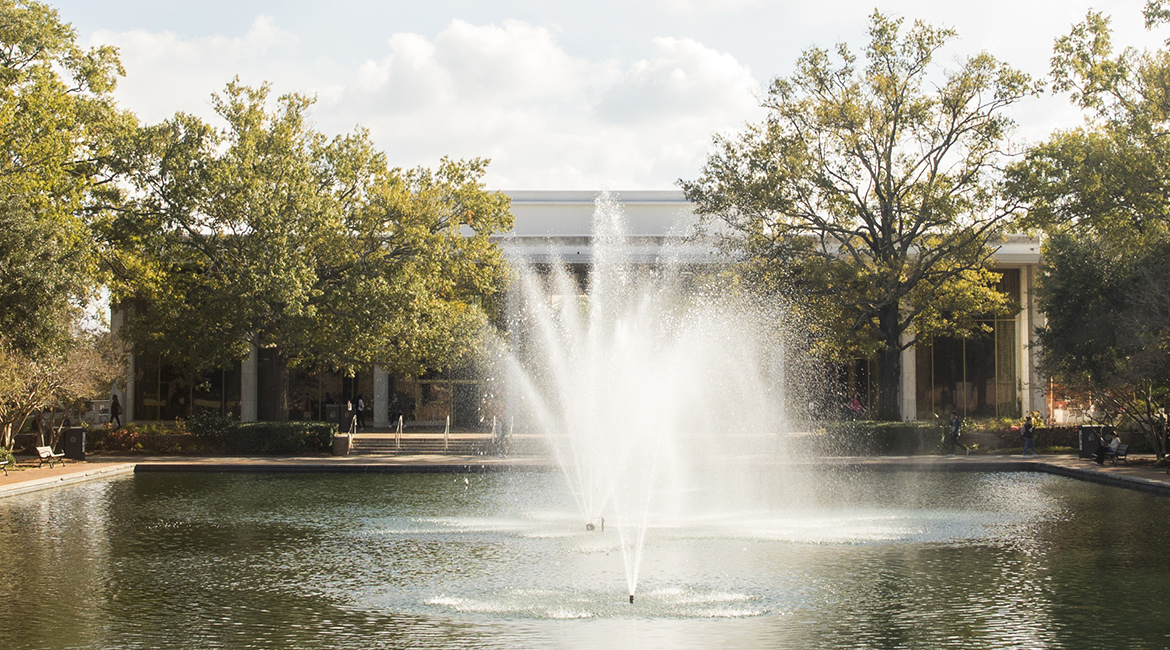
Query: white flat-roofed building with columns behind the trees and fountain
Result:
<box><xmin>111</xmin><ymin>191</ymin><xmax>1046</xmax><ymax>428</ymax></box>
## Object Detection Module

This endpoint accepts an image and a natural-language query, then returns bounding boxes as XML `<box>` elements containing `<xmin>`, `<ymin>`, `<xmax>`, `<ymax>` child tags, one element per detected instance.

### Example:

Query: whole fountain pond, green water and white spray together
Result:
<box><xmin>0</xmin><ymin>199</ymin><xmax>1170</xmax><ymax>650</ymax></box>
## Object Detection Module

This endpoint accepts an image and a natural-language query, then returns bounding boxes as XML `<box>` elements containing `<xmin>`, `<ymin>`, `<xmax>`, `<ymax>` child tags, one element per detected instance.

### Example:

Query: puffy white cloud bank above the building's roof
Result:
<box><xmin>92</xmin><ymin>16</ymin><xmax>761</xmax><ymax>188</ymax></box>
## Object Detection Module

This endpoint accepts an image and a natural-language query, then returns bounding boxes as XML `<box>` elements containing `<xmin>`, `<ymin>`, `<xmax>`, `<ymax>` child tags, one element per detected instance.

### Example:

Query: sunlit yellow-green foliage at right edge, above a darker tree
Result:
<box><xmin>1007</xmin><ymin>7</ymin><xmax>1170</xmax><ymax>237</ymax></box>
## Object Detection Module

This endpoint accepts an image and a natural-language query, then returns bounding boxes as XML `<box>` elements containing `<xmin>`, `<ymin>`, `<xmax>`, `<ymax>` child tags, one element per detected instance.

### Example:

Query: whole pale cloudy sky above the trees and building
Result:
<box><xmin>47</xmin><ymin>0</ymin><xmax>1170</xmax><ymax>191</ymax></box>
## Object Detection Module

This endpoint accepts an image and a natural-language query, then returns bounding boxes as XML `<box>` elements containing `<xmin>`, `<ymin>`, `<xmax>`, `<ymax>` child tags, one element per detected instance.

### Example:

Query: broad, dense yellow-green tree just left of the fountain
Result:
<box><xmin>103</xmin><ymin>82</ymin><xmax>511</xmax><ymax>420</ymax></box>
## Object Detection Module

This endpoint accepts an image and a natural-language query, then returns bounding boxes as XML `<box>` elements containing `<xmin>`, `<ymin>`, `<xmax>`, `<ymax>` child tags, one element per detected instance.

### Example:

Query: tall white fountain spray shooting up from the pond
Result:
<box><xmin>509</xmin><ymin>194</ymin><xmax>784</xmax><ymax>603</ymax></box>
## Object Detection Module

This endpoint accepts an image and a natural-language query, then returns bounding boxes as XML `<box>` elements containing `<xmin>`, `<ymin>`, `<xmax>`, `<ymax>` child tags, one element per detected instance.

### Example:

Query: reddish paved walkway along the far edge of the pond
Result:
<box><xmin>0</xmin><ymin>455</ymin><xmax>1170</xmax><ymax>498</ymax></box>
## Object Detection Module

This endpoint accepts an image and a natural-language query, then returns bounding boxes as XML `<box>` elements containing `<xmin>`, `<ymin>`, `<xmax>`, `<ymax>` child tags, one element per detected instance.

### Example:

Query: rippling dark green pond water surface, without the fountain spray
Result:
<box><xmin>0</xmin><ymin>472</ymin><xmax>1170</xmax><ymax>649</ymax></box>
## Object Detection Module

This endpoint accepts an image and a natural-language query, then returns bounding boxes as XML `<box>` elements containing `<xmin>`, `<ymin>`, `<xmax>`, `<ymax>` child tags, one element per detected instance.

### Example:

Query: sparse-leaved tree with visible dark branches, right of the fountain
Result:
<box><xmin>682</xmin><ymin>12</ymin><xmax>1035</xmax><ymax>419</ymax></box>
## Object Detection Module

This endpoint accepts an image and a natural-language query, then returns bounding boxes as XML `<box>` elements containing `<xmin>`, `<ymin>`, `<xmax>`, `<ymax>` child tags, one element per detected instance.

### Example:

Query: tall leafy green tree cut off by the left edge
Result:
<box><xmin>0</xmin><ymin>0</ymin><xmax>132</xmax><ymax>447</ymax></box>
